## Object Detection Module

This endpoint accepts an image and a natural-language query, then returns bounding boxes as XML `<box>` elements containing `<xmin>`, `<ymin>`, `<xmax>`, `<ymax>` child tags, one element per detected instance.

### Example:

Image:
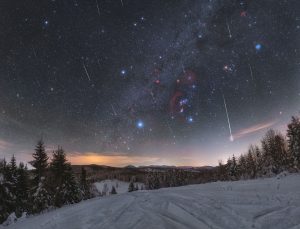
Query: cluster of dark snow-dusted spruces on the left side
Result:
<box><xmin>0</xmin><ymin>140</ymin><xmax>93</xmax><ymax>223</ymax></box>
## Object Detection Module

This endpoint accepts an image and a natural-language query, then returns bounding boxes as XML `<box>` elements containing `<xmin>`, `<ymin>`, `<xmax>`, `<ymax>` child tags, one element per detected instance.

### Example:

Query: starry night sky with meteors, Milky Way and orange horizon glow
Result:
<box><xmin>0</xmin><ymin>0</ymin><xmax>300</xmax><ymax>166</ymax></box>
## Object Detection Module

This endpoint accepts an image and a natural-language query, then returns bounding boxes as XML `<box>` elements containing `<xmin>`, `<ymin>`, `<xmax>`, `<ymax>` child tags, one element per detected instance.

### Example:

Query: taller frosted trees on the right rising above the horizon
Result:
<box><xmin>217</xmin><ymin>117</ymin><xmax>300</xmax><ymax>180</ymax></box>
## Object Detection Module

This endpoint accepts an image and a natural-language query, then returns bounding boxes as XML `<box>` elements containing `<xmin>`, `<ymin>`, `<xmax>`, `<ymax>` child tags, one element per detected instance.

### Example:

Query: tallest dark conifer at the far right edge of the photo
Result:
<box><xmin>287</xmin><ymin>116</ymin><xmax>300</xmax><ymax>169</ymax></box>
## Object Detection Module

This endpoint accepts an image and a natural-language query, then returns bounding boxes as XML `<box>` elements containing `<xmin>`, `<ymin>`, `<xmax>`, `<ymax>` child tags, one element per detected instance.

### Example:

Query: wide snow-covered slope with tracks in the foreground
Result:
<box><xmin>2</xmin><ymin>174</ymin><xmax>300</xmax><ymax>229</ymax></box>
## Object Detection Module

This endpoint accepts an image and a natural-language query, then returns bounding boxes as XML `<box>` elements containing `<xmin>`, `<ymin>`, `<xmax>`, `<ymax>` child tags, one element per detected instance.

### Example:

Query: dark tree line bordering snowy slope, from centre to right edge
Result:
<box><xmin>144</xmin><ymin>117</ymin><xmax>300</xmax><ymax>189</ymax></box>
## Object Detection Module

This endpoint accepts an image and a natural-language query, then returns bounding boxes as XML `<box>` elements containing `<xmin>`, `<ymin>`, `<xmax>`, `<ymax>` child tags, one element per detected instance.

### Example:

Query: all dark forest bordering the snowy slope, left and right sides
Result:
<box><xmin>0</xmin><ymin>117</ymin><xmax>300</xmax><ymax>223</ymax></box>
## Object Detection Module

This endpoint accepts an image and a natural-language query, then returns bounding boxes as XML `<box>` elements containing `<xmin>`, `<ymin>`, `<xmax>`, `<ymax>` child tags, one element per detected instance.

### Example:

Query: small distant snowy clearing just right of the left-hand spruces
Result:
<box><xmin>94</xmin><ymin>180</ymin><xmax>144</xmax><ymax>195</ymax></box>
